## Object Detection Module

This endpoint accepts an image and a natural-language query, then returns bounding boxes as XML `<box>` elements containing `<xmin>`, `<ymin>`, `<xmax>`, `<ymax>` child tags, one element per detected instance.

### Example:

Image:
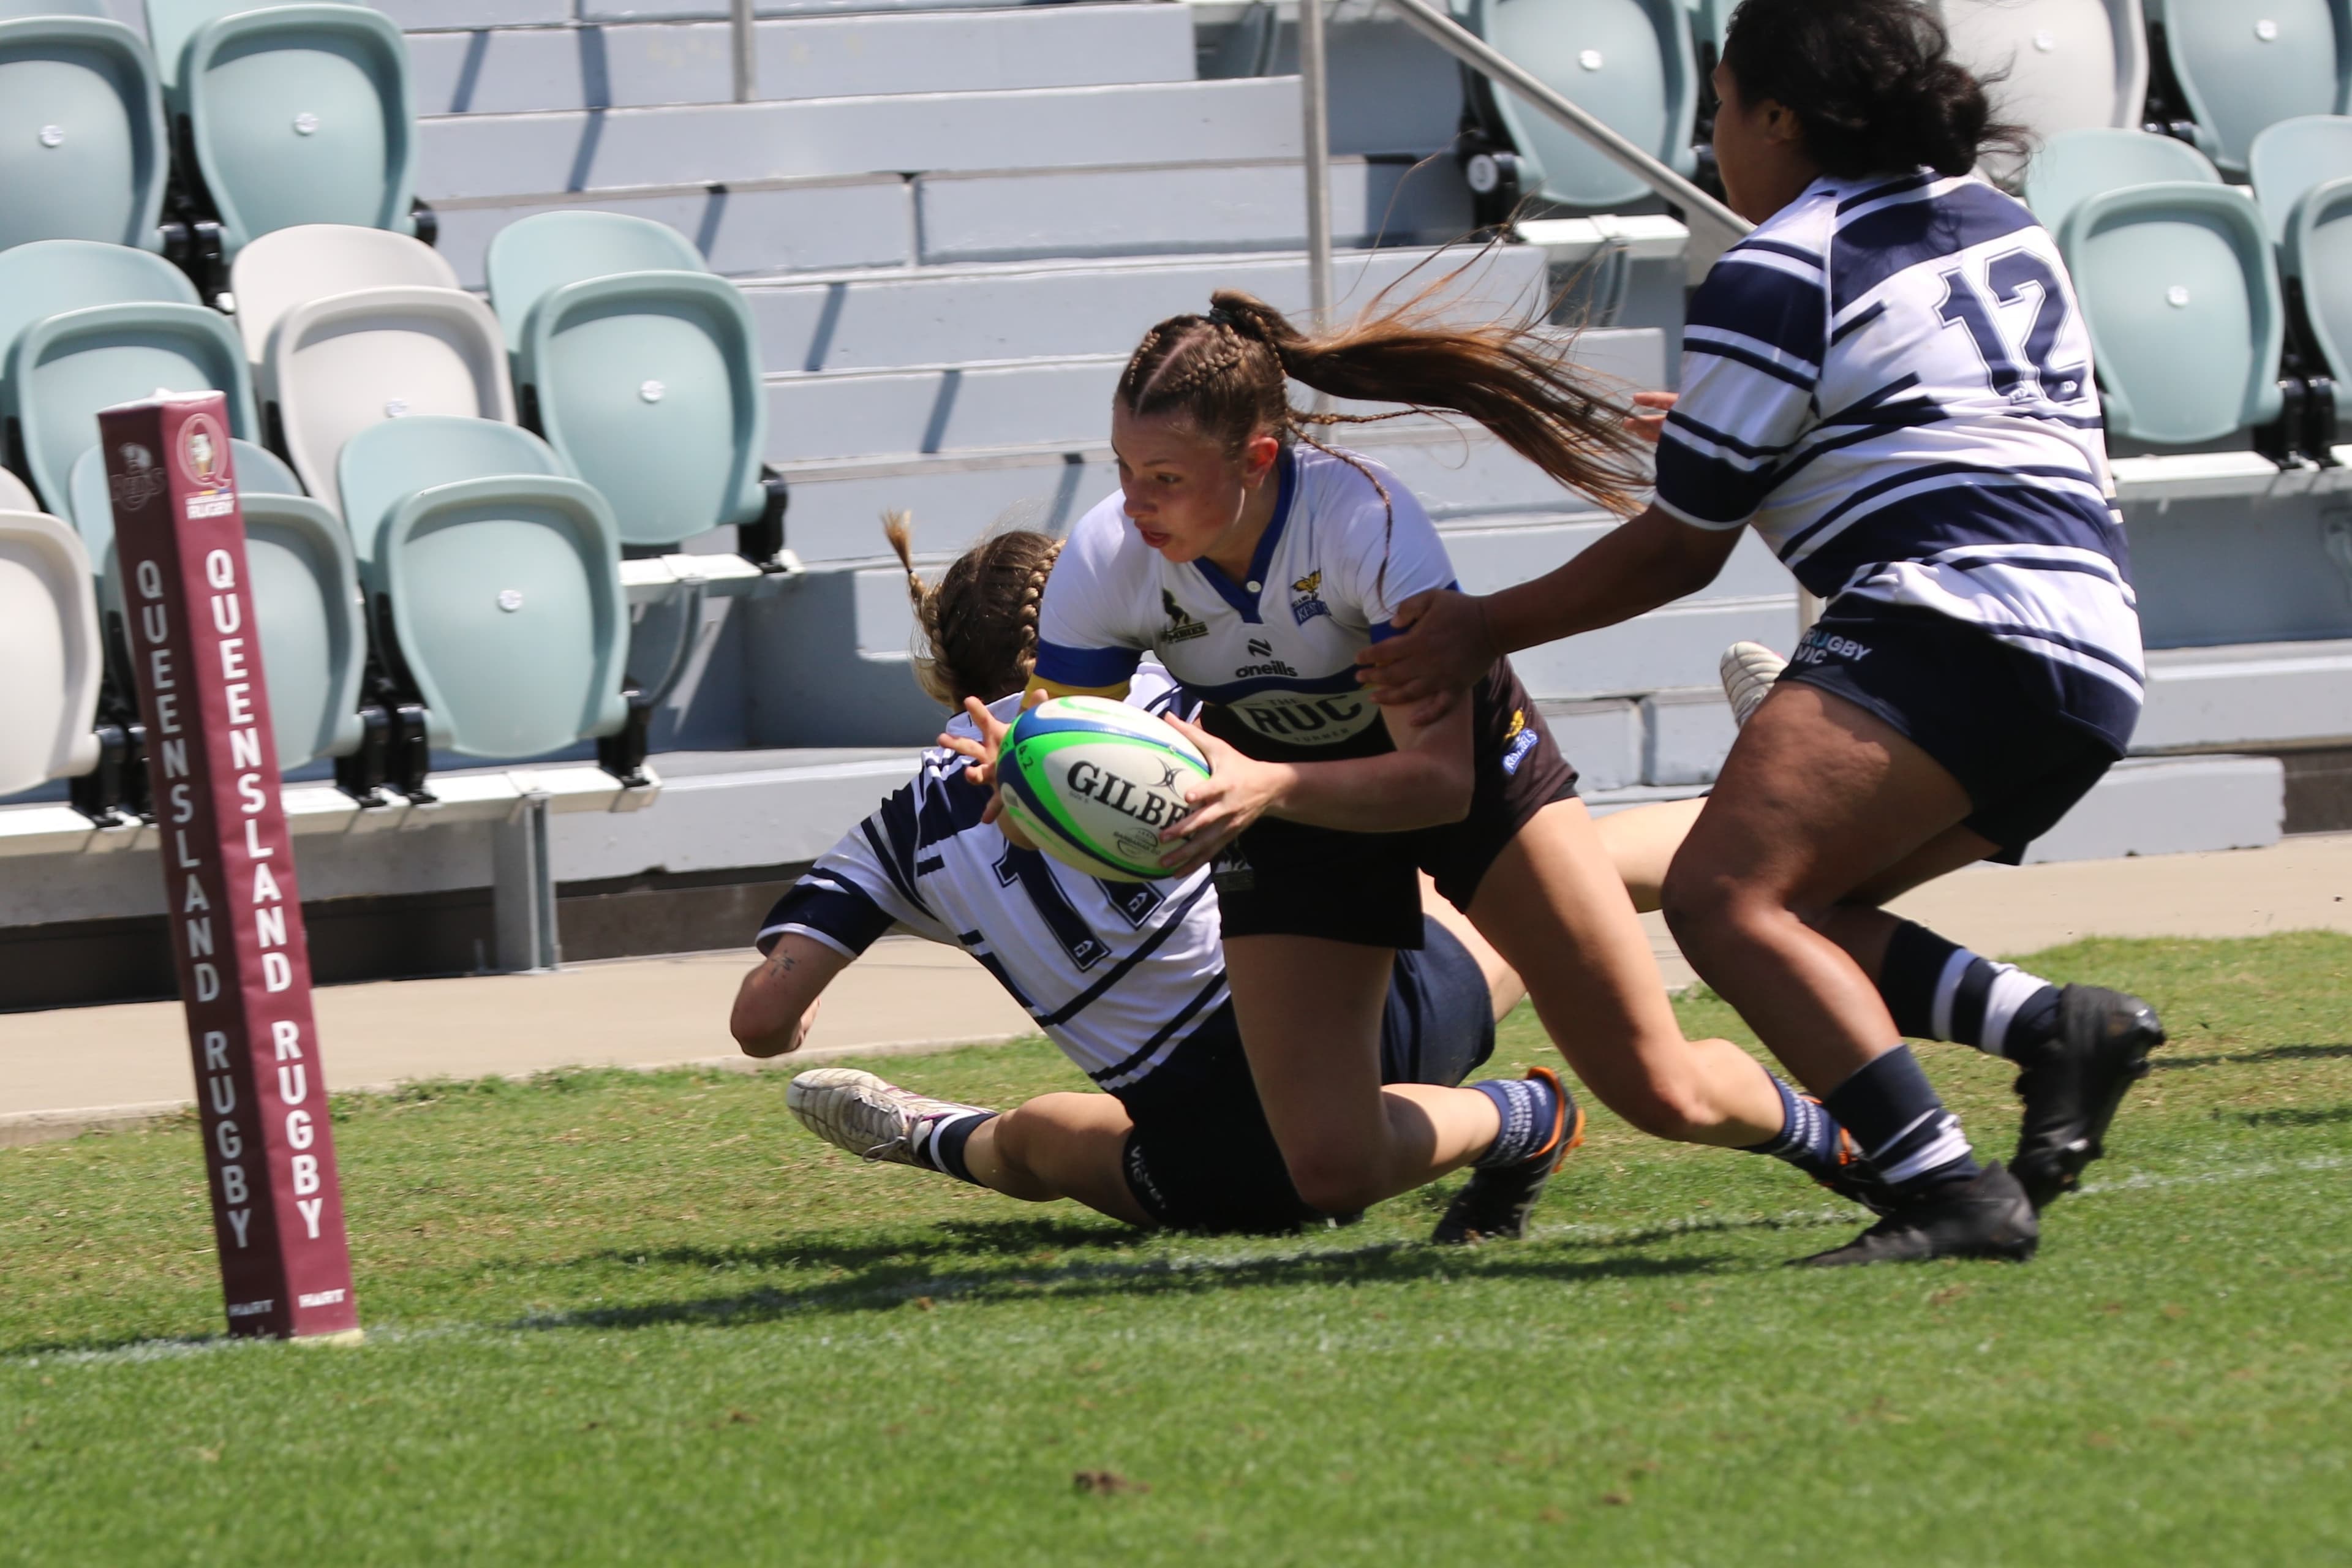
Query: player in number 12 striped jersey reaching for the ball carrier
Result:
<box><xmin>1364</xmin><ymin>0</ymin><xmax>2164</xmax><ymax>1265</ymax></box>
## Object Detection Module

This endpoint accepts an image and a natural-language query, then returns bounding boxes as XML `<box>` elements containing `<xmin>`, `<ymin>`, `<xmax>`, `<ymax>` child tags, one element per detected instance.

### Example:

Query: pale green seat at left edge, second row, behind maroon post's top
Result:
<box><xmin>0</xmin><ymin>239</ymin><xmax>258</xmax><ymax>510</ymax></box>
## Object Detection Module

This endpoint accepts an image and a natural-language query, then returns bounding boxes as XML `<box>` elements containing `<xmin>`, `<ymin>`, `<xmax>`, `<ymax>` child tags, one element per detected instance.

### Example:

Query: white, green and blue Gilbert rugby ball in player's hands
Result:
<box><xmin>997</xmin><ymin>696</ymin><xmax>1209</xmax><ymax>881</ymax></box>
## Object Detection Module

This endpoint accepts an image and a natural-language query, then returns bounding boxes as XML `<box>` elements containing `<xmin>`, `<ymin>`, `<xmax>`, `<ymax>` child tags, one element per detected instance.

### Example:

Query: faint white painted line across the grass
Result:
<box><xmin>13</xmin><ymin>1154</ymin><xmax>2352</xmax><ymax>1368</ymax></box>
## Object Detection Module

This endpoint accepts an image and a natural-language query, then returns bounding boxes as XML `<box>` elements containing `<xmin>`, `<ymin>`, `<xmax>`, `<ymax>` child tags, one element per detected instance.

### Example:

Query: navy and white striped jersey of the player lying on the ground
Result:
<box><xmin>760</xmin><ymin>665</ymin><xmax>1230</xmax><ymax>1091</ymax></box>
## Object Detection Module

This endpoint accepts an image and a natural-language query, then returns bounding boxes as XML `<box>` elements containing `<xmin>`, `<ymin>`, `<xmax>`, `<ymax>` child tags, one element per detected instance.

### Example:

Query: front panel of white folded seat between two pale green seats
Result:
<box><xmin>261</xmin><ymin>287</ymin><xmax>515</xmax><ymax>515</ymax></box>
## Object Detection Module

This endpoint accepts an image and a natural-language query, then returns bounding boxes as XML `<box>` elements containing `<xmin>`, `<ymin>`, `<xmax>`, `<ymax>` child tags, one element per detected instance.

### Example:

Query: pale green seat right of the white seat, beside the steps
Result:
<box><xmin>489</xmin><ymin>214</ymin><xmax>769</xmax><ymax>548</ymax></box>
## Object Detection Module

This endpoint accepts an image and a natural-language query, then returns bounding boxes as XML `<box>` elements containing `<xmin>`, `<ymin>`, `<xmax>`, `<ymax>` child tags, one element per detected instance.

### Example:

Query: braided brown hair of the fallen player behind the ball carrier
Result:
<box><xmin>882</xmin><ymin>513</ymin><xmax>1061</xmax><ymax>707</ymax></box>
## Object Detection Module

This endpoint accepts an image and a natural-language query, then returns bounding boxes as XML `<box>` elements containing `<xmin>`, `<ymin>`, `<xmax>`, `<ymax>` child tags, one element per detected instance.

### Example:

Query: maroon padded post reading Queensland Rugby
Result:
<box><xmin>99</xmin><ymin>393</ymin><xmax>360</xmax><ymax>1338</ymax></box>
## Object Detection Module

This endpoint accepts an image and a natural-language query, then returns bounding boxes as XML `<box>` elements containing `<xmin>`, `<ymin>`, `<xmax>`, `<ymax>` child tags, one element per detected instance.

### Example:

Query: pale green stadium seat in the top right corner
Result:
<box><xmin>2152</xmin><ymin>0</ymin><xmax>2352</xmax><ymax>176</ymax></box>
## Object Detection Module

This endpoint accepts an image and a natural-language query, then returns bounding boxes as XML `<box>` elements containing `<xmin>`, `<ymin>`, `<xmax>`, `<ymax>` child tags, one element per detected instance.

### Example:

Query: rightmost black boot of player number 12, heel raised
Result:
<box><xmin>2008</xmin><ymin>985</ymin><xmax>2164</xmax><ymax>1211</ymax></box>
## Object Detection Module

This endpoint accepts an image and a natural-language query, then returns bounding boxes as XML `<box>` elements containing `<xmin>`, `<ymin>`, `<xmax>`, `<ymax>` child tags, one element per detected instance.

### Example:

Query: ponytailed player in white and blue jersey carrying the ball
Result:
<box><xmin>952</xmin><ymin>294</ymin><xmax>1900</xmax><ymax>1213</ymax></box>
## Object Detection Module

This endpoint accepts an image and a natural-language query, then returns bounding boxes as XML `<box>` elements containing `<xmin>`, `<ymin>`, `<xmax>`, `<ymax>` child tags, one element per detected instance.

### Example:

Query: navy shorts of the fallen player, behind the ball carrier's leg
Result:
<box><xmin>1117</xmin><ymin>922</ymin><xmax>1493</xmax><ymax>1232</ymax></box>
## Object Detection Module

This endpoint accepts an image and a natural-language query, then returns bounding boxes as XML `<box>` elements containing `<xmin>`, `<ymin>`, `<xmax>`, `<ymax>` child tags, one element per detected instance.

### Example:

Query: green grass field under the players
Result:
<box><xmin>0</xmin><ymin>936</ymin><xmax>2352</xmax><ymax>1568</ymax></box>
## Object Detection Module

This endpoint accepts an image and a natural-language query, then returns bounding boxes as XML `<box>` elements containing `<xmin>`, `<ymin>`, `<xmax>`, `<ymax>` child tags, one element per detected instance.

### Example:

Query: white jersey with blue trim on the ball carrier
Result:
<box><xmin>1037</xmin><ymin>447</ymin><xmax>1453</xmax><ymax>760</ymax></box>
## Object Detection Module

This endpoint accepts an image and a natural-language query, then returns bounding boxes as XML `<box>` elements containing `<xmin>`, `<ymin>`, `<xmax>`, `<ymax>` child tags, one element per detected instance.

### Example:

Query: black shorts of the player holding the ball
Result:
<box><xmin>1213</xmin><ymin>658</ymin><xmax>1576</xmax><ymax>950</ymax></box>
